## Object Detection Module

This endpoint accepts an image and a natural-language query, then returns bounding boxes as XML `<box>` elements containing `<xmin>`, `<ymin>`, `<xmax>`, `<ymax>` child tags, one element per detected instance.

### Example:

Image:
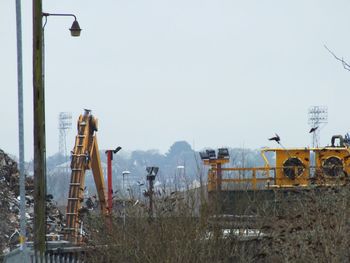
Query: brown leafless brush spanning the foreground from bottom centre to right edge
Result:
<box><xmin>82</xmin><ymin>187</ymin><xmax>350</xmax><ymax>263</ymax></box>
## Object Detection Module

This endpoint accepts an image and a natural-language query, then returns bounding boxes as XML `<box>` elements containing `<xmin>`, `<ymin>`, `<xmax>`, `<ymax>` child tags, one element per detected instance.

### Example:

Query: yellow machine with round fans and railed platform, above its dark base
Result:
<box><xmin>200</xmin><ymin>135</ymin><xmax>350</xmax><ymax>192</ymax></box>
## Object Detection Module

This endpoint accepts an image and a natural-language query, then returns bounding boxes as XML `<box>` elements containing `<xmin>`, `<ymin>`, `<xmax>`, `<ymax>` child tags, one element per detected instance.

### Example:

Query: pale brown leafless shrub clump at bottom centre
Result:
<box><xmin>86</xmin><ymin>190</ymin><xmax>270</xmax><ymax>263</ymax></box>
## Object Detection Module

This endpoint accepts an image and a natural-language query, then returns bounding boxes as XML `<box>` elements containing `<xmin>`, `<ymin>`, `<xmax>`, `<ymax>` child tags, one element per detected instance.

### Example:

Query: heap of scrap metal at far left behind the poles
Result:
<box><xmin>0</xmin><ymin>149</ymin><xmax>64</xmax><ymax>254</ymax></box>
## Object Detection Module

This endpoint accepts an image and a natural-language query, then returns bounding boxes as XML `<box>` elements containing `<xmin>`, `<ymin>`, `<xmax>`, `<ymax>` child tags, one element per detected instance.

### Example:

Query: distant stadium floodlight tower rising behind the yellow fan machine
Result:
<box><xmin>308</xmin><ymin>106</ymin><xmax>328</xmax><ymax>147</ymax></box>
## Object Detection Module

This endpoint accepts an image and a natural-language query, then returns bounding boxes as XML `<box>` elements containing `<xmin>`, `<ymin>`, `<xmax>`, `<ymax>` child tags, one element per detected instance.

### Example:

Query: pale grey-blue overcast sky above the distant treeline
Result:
<box><xmin>0</xmin><ymin>0</ymin><xmax>350</xmax><ymax>160</ymax></box>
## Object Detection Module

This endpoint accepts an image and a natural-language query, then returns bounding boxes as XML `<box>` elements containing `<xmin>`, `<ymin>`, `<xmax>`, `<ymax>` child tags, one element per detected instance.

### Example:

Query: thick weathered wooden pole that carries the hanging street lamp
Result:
<box><xmin>33</xmin><ymin>0</ymin><xmax>46</xmax><ymax>259</ymax></box>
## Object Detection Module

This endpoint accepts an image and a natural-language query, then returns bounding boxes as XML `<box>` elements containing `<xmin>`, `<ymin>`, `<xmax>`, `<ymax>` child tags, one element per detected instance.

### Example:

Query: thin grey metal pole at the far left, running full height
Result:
<box><xmin>16</xmin><ymin>0</ymin><xmax>27</xmax><ymax>262</ymax></box>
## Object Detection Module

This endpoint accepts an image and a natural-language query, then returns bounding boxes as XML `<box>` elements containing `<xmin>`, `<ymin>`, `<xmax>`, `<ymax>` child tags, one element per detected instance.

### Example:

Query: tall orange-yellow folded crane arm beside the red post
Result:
<box><xmin>65</xmin><ymin>110</ymin><xmax>108</xmax><ymax>243</ymax></box>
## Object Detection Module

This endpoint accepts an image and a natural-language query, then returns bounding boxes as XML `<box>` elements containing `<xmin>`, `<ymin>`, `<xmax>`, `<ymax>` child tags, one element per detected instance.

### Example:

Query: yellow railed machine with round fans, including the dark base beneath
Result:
<box><xmin>200</xmin><ymin>135</ymin><xmax>350</xmax><ymax>217</ymax></box>
